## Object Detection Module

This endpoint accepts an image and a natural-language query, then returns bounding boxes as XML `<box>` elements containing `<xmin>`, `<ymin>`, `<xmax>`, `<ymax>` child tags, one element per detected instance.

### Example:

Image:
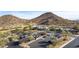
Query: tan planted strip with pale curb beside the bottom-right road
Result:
<box><xmin>48</xmin><ymin>36</ymin><xmax>75</xmax><ymax>48</ymax></box>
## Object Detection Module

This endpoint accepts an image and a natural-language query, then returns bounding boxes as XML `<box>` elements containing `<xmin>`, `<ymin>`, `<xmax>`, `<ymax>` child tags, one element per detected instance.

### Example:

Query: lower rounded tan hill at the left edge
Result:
<box><xmin>0</xmin><ymin>15</ymin><xmax>28</xmax><ymax>27</ymax></box>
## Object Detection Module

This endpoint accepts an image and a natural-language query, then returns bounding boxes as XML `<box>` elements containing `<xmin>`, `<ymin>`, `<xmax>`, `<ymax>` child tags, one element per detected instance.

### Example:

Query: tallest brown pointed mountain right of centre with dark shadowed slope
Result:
<box><xmin>31</xmin><ymin>12</ymin><xmax>75</xmax><ymax>26</ymax></box>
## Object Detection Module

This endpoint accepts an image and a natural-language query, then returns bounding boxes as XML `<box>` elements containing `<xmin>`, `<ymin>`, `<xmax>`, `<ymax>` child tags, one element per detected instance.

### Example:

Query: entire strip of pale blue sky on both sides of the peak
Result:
<box><xmin>0</xmin><ymin>11</ymin><xmax>79</xmax><ymax>20</ymax></box>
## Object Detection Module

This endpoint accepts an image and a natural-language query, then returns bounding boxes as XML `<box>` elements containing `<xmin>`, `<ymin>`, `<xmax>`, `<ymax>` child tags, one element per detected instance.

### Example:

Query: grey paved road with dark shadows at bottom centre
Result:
<box><xmin>29</xmin><ymin>37</ymin><xmax>51</xmax><ymax>48</ymax></box>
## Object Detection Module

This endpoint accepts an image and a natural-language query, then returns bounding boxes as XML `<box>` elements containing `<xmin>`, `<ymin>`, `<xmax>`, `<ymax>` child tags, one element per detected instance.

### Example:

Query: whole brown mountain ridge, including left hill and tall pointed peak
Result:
<box><xmin>0</xmin><ymin>12</ymin><xmax>79</xmax><ymax>28</ymax></box>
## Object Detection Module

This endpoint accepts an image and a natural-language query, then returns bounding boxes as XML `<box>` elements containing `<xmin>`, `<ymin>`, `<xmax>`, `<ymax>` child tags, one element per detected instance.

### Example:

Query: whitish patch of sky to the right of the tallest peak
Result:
<box><xmin>53</xmin><ymin>11</ymin><xmax>79</xmax><ymax>20</ymax></box>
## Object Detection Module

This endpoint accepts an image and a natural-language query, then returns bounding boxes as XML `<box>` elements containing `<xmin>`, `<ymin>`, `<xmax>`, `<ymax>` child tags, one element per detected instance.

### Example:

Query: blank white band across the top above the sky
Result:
<box><xmin>0</xmin><ymin>0</ymin><xmax>79</xmax><ymax>11</ymax></box>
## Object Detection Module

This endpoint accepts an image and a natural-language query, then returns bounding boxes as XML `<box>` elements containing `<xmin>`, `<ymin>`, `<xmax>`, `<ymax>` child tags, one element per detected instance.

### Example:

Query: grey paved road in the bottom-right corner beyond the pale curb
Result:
<box><xmin>63</xmin><ymin>36</ymin><xmax>79</xmax><ymax>48</ymax></box>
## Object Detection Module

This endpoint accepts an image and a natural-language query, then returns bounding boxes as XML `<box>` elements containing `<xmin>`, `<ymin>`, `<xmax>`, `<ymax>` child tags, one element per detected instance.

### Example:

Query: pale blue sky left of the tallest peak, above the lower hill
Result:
<box><xmin>0</xmin><ymin>11</ymin><xmax>45</xmax><ymax>19</ymax></box>
